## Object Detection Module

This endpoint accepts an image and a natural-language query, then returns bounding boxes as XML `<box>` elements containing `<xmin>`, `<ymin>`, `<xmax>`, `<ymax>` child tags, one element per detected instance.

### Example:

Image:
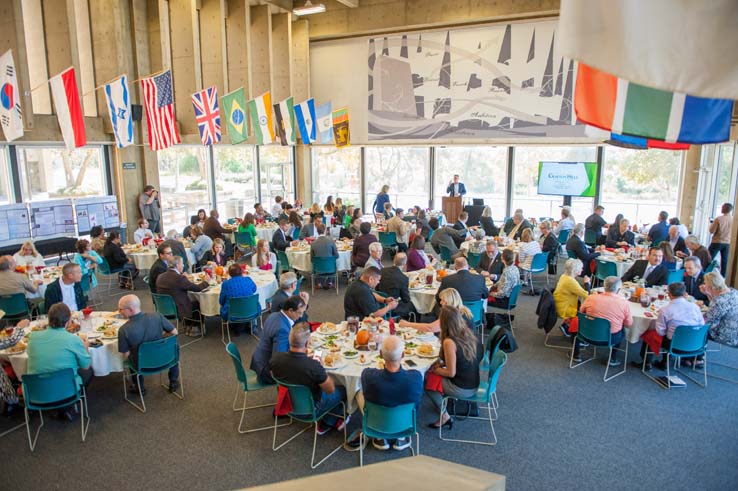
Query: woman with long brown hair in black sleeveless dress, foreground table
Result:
<box><xmin>425</xmin><ymin>307</ymin><xmax>484</xmax><ymax>429</ymax></box>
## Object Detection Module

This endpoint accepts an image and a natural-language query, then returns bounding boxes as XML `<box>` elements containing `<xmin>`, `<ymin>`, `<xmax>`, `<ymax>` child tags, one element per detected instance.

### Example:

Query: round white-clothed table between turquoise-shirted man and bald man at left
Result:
<box><xmin>0</xmin><ymin>312</ymin><xmax>126</xmax><ymax>377</ymax></box>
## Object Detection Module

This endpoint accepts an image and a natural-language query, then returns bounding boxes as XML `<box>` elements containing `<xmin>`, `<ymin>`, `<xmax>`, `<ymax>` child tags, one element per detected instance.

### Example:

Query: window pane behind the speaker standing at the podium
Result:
<box><xmin>433</xmin><ymin>146</ymin><xmax>507</xmax><ymax>218</ymax></box>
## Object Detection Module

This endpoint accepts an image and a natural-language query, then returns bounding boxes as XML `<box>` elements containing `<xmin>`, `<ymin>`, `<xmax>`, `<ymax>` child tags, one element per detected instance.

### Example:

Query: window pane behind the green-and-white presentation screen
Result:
<box><xmin>512</xmin><ymin>147</ymin><xmax>600</xmax><ymax>223</ymax></box>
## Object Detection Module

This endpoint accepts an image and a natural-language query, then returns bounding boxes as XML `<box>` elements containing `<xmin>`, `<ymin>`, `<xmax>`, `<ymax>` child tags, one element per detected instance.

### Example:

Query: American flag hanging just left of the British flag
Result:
<box><xmin>141</xmin><ymin>70</ymin><xmax>181</xmax><ymax>151</ymax></box>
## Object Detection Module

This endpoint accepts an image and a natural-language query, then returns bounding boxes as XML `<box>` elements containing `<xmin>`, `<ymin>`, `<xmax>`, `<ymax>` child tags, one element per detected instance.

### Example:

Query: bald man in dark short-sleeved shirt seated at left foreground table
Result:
<box><xmin>118</xmin><ymin>295</ymin><xmax>179</xmax><ymax>395</ymax></box>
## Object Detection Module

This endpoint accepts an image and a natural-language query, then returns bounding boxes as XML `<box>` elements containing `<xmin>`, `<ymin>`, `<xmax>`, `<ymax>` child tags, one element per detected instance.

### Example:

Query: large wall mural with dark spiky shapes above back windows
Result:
<box><xmin>367</xmin><ymin>21</ymin><xmax>585</xmax><ymax>140</ymax></box>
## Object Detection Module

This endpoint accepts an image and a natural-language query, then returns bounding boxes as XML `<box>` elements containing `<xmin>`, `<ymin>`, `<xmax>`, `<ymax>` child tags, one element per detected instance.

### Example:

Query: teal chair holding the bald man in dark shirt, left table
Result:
<box><xmin>123</xmin><ymin>336</ymin><xmax>184</xmax><ymax>413</ymax></box>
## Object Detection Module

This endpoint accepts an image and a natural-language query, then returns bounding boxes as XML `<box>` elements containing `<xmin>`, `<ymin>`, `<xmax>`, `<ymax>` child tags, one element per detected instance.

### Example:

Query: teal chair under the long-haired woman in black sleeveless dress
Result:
<box><xmin>438</xmin><ymin>351</ymin><xmax>507</xmax><ymax>446</ymax></box>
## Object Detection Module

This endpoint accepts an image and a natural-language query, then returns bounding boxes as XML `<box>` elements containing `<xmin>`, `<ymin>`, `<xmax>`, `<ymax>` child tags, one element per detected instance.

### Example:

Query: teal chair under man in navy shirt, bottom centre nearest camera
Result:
<box><xmin>359</xmin><ymin>401</ymin><xmax>420</xmax><ymax>467</ymax></box>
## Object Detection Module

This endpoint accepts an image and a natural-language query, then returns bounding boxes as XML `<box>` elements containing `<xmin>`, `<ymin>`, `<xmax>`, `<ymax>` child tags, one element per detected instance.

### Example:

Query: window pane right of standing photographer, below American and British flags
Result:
<box><xmin>158</xmin><ymin>145</ymin><xmax>211</xmax><ymax>230</ymax></box>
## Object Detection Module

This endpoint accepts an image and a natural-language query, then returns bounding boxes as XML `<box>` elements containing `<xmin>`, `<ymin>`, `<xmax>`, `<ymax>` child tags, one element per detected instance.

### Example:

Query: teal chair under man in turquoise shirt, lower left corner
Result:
<box><xmin>21</xmin><ymin>368</ymin><xmax>90</xmax><ymax>452</ymax></box>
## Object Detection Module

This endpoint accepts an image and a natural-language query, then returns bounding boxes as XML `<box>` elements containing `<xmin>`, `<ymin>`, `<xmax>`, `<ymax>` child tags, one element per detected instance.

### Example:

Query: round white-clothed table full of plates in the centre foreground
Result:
<box><xmin>311</xmin><ymin>321</ymin><xmax>440</xmax><ymax>414</ymax></box>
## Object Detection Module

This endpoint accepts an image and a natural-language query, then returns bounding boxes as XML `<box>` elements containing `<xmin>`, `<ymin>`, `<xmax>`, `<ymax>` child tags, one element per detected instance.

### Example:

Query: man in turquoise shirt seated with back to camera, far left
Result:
<box><xmin>26</xmin><ymin>303</ymin><xmax>92</xmax><ymax>421</ymax></box>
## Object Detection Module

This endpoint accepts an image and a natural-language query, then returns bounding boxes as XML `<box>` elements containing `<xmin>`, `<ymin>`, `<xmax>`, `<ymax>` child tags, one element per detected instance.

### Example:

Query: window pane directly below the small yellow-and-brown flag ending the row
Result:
<box><xmin>312</xmin><ymin>147</ymin><xmax>361</xmax><ymax>206</ymax></box>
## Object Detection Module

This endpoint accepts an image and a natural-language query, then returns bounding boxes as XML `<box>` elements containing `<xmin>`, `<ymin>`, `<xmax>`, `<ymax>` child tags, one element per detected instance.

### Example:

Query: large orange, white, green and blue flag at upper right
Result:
<box><xmin>574</xmin><ymin>63</ymin><xmax>733</xmax><ymax>144</ymax></box>
